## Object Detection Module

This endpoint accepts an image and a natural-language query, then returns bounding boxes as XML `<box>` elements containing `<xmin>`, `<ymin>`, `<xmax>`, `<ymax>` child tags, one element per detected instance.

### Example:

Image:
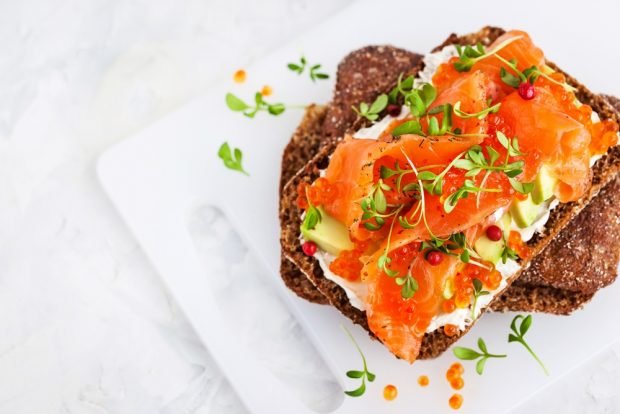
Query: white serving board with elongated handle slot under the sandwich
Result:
<box><xmin>98</xmin><ymin>1</ymin><xmax>620</xmax><ymax>413</ymax></box>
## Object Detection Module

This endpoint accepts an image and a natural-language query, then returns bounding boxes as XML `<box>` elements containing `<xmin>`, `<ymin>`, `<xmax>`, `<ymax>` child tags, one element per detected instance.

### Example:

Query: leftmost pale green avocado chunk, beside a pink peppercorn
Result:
<box><xmin>301</xmin><ymin>207</ymin><xmax>354</xmax><ymax>256</ymax></box>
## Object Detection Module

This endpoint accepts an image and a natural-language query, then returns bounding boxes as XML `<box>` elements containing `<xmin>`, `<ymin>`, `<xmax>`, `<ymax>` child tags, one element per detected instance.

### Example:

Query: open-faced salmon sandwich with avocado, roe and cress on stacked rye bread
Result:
<box><xmin>280</xmin><ymin>28</ymin><xmax>620</xmax><ymax>362</ymax></box>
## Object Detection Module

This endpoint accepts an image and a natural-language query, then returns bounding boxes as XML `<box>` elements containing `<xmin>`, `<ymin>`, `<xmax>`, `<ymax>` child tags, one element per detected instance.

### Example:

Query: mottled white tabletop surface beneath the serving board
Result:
<box><xmin>0</xmin><ymin>0</ymin><xmax>620</xmax><ymax>414</ymax></box>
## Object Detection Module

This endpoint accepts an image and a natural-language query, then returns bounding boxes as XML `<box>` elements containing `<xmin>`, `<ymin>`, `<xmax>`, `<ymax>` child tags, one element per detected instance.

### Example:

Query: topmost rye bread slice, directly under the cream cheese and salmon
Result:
<box><xmin>280</xmin><ymin>29</ymin><xmax>620</xmax><ymax>359</ymax></box>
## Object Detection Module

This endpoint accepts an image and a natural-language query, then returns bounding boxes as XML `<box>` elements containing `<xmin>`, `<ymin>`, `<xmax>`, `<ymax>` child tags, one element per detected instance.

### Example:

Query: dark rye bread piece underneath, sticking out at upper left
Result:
<box><xmin>280</xmin><ymin>46</ymin><xmax>422</xmax><ymax>304</ymax></box>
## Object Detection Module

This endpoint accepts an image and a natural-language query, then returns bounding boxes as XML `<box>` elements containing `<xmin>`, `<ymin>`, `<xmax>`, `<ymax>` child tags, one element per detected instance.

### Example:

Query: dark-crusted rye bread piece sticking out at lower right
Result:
<box><xmin>491</xmin><ymin>177</ymin><xmax>620</xmax><ymax>315</ymax></box>
